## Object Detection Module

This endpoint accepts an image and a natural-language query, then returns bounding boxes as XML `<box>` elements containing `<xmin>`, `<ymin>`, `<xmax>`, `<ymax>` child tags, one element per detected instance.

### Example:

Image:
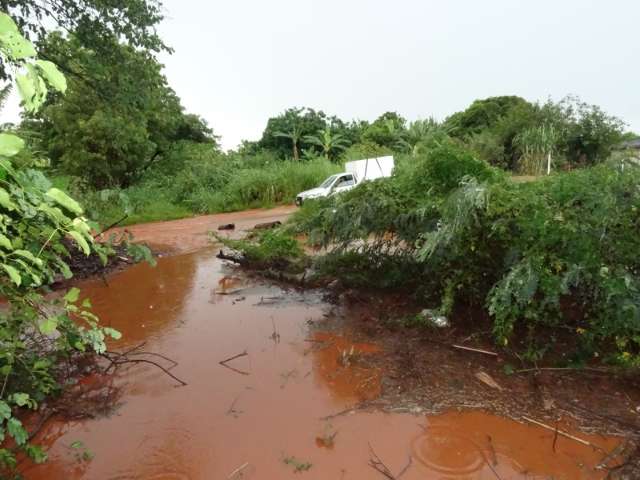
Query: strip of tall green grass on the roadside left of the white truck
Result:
<box><xmin>70</xmin><ymin>154</ymin><xmax>341</xmax><ymax>226</ymax></box>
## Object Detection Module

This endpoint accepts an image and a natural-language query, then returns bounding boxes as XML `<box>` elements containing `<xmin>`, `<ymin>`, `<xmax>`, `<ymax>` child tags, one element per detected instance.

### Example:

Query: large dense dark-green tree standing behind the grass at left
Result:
<box><xmin>34</xmin><ymin>34</ymin><xmax>216</xmax><ymax>188</ymax></box>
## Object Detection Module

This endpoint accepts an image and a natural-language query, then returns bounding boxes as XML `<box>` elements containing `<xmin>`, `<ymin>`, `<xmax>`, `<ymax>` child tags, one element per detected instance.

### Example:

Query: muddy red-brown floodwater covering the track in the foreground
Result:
<box><xmin>18</xmin><ymin>249</ymin><xmax>618</xmax><ymax>480</ymax></box>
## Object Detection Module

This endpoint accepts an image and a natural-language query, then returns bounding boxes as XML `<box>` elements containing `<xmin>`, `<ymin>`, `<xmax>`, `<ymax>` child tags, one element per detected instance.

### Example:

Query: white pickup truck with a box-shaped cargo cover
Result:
<box><xmin>296</xmin><ymin>155</ymin><xmax>394</xmax><ymax>206</ymax></box>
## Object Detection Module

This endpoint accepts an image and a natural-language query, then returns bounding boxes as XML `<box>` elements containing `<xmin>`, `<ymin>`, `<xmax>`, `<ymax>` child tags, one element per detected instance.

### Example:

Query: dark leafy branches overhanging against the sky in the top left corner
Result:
<box><xmin>0</xmin><ymin>0</ymin><xmax>169</xmax><ymax>79</ymax></box>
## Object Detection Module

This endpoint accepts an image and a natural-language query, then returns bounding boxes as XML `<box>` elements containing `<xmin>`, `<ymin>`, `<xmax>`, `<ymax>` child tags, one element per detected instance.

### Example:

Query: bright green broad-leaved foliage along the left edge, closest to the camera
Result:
<box><xmin>0</xmin><ymin>12</ymin><xmax>131</xmax><ymax>472</ymax></box>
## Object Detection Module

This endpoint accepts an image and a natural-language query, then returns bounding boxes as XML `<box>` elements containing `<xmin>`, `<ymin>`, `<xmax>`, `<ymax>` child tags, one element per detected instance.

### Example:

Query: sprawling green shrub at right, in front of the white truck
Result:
<box><xmin>288</xmin><ymin>144</ymin><xmax>640</xmax><ymax>365</ymax></box>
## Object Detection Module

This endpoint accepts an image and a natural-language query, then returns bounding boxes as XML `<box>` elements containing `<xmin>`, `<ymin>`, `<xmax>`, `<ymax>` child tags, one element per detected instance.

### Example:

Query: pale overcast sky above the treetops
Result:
<box><xmin>1</xmin><ymin>0</ymin><xmax>640</xmax><ymax>148</ymax></box>
